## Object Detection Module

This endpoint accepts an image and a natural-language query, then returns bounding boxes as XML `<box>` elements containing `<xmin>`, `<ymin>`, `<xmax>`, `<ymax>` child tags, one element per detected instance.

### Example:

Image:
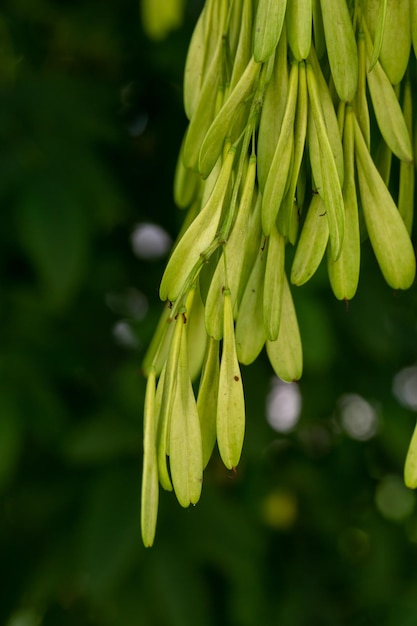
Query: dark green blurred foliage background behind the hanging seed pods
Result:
<box><xmin>0</xmin><ymin>0</ymin><xmax>417</xmax><ymax>626</ymax></box>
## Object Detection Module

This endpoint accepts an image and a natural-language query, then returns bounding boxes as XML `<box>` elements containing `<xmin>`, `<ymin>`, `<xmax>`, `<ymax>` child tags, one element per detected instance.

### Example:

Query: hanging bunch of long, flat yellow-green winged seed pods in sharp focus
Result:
<box><xmin>142</xmin><ymin>0</ymin><xmax>417</xmax><ymax>546</ymax></box>
